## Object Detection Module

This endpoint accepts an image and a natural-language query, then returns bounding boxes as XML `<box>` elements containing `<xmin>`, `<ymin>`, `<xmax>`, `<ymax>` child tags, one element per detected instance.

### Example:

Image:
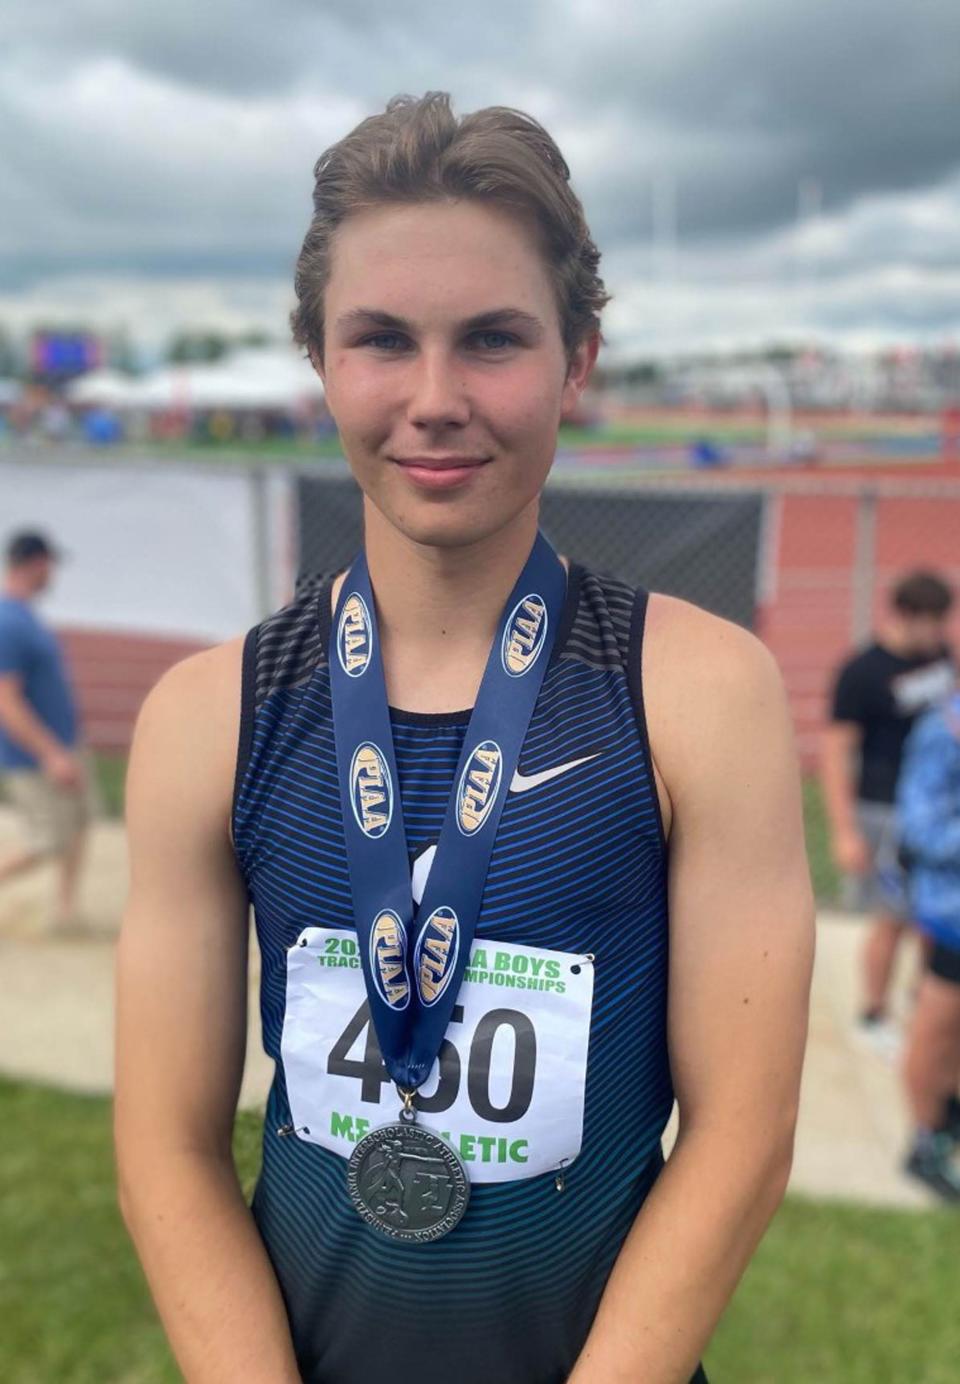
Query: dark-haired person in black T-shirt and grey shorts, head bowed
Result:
<box><xmin>822</xmin><ymin>572</ymin><xmax>953</xmax><ymax>1056</ymax></box>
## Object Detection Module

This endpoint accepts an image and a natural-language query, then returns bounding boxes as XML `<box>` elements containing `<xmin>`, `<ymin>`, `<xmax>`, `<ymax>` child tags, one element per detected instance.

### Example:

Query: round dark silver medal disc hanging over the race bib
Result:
<box><xmin>347</xmin><ymin>1121</ymin><xmax>470</xmax><ymax>1244</ymax></box>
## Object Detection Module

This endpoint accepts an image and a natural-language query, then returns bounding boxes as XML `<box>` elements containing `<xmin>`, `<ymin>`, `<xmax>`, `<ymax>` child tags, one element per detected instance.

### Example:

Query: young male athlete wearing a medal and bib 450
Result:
<box><xmin>116</xmin><ymin>93</ymin><xmax>813</xmax><ymax>1384</ymax></box>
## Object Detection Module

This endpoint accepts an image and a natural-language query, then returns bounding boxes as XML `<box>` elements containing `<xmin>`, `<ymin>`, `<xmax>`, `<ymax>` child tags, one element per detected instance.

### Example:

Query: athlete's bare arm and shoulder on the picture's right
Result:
<box><xmin>570</xmin><ymin>597</ymin><xmax>813</xmax><ymax>1384</ymax></box>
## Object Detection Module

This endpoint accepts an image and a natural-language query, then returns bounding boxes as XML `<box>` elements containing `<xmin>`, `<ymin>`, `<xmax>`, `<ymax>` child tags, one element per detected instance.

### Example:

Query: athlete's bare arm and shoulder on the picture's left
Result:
<box><xmin>115</xmin><ymin>641</ymin><xmax>300</xmax><ymax>1384</ymax></box>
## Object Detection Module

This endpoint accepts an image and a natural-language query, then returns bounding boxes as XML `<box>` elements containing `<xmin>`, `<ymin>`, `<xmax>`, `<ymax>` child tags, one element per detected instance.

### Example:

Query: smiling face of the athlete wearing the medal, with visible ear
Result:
<box><xmin>315</xmin><ymin>202</ymin><xmax>598</xmax><ymax>547</ymax></box>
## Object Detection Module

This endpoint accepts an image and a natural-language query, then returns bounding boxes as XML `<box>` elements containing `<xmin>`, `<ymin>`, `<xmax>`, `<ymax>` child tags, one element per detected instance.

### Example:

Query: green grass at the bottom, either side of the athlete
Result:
<box><xmin>0</xmin><ymin>1078</ymin><xmax>960</xmax><ymax>1384</ymax></box>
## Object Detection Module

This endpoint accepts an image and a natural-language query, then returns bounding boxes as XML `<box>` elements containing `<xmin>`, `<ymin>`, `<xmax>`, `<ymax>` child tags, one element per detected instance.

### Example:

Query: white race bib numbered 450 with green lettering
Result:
<box><xmin>281</xmin><ymin>927</ymin><xmax>593</xmax><ymax>1182</ymax></box>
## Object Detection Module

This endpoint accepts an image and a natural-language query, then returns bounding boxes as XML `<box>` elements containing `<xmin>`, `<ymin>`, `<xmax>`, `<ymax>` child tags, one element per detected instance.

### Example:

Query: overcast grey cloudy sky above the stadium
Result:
<box><xmin>0</xmin><ymin>0</ymin><xmax>960</xmax><ymax>353</ymax></box>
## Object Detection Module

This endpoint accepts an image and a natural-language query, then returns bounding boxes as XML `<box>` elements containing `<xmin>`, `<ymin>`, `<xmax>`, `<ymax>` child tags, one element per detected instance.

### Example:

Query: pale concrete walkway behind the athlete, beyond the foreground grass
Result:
<box><xmin>0</xmin><ymin>812</ymin><xmax>935</xmax><ymax>1207</ymax></box>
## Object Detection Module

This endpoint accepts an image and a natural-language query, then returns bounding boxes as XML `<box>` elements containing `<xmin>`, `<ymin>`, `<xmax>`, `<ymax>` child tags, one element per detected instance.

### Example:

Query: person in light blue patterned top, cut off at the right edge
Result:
<box><xmin>896</xmin><ymin>689</ymin><xmax>960</xmax><ymax>1203</ymax></box>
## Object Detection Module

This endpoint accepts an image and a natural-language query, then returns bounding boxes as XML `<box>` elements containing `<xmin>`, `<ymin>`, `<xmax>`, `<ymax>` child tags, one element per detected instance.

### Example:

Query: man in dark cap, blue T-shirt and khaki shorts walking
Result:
<box><xmin>0</xmin><ymin>531</ymin><xmax>94</xmax><ymax>927</ymax></box>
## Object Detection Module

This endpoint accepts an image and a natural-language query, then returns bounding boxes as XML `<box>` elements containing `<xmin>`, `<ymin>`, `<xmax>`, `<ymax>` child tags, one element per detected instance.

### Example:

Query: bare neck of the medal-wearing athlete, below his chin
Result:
<box><xmin>364</xmin><ymin>502</ymin><xmax>553</xmax><ymax>655</ymax></box>
